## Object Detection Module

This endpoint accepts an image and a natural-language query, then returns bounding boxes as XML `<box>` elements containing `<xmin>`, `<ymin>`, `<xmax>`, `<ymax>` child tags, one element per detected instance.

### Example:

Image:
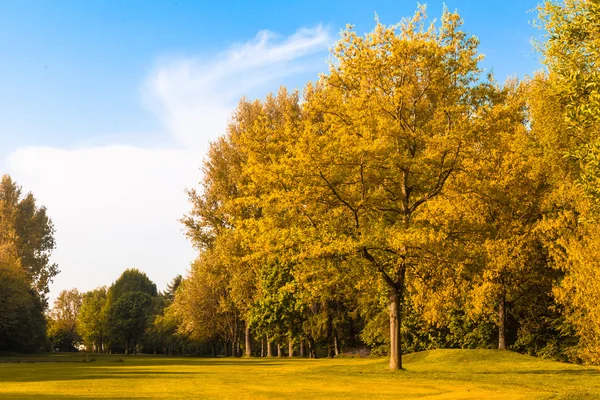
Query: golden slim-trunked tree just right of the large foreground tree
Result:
<box><xmin>457</xmin><ymin>81</ymin><xmax>555</xmax><ymax>349</ymax></box>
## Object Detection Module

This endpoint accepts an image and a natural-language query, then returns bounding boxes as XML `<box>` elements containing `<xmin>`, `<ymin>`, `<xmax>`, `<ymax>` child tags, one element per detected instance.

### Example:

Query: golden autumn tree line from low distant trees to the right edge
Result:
<box><xmin>0</xmin><ymin>0</ymin><xmax>600</xmax><ymax>369</ymax></box>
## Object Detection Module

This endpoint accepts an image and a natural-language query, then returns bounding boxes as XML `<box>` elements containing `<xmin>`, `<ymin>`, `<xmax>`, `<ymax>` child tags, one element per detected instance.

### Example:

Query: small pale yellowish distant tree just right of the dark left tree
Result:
<box><xmin>48</xmin><ymin>289</ymin><xmax>82</xmax><ymax>351</ymax></box>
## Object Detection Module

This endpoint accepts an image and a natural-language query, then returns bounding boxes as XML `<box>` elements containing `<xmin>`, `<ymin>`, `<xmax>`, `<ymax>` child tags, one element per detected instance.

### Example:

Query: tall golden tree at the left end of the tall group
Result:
<box><xmin>183</xmin><ymin>89</ymin><xmax>300</xmax><ymax>355</ymax></box>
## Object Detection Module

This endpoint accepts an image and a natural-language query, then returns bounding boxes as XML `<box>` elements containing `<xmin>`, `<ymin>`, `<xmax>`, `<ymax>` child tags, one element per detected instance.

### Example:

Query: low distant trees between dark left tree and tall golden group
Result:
<box><xmin>48</xmin><ymin>269</ymin><xmax>185</xmax><ymax>355</ymax></box>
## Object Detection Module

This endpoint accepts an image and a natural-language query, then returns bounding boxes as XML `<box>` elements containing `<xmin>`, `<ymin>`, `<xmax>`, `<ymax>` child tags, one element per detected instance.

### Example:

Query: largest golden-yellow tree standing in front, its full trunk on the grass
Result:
<box><xmin>281</xmin><ymin>7</ymin><xmax>481</xmax><ymax>369</ymax></box>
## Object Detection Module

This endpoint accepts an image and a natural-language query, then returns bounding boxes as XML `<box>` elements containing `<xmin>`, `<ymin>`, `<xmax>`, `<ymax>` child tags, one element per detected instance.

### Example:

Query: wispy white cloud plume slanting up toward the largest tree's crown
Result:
<box><xmin>144</xmin><ymin>26</ymin><xmax>331</xmax><ymax>149</ymax></box>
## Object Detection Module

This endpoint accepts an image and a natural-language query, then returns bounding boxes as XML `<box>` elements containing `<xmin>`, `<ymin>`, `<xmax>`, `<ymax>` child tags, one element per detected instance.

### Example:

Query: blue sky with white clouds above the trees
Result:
<box><xmin>0</xmin><ymin>0</ymin><xmax>541</xmax><ymax>299</ymax></box>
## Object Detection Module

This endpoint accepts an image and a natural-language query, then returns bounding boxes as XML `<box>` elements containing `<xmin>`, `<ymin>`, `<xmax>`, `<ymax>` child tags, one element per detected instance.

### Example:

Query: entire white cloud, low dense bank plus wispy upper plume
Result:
<box><xmin>7</xmin><ymin>26</ymin><xmax>331</xmax><ymax>297</ymax></box>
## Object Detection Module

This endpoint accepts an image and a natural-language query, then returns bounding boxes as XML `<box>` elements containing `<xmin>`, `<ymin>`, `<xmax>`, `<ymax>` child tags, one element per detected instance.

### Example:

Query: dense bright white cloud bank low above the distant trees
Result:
<box><xmin>8</xmin><ymin>146</ymin><xmax>200</xmax><ymax>296</ymax></box>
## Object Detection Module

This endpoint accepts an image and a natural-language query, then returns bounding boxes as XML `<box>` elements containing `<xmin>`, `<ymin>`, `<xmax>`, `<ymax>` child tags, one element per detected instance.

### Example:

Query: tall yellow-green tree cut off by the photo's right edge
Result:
<box><xmin>532</xmin><ymin>0</ymin><xmax>600</xmax><ymax>363</ymax></box>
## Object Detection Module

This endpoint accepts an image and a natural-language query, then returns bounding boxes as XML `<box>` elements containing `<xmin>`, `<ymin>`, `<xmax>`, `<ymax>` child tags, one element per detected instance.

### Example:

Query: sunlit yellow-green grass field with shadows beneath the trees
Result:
<box><xmin>0</xmin><ymin>350</ymin><xmax>600</xmax><ymax>400</ymax></box>
